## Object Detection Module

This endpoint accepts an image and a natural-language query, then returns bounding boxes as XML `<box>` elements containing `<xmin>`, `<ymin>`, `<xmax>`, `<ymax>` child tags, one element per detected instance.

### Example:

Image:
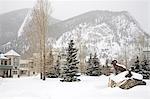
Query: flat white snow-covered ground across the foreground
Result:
<box><xmin>0</xmin><ymin>76</ymin><xmax>150</xmax><ymax>99</ymax></box>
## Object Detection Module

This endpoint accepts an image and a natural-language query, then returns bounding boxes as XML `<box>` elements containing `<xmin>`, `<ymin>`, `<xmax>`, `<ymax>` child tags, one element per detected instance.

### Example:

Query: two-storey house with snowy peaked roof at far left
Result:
<box><xmin>0</xmin><ymin>50</ymin><xmax>20</xmax><ymax>77</ymax></box>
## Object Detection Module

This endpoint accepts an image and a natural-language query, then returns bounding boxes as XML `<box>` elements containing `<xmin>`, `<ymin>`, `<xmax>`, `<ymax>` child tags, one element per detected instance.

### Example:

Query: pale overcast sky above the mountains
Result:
<box><xmin>0</xmin><ymin>0</ymin><xmax>150</xmax><ymax>33</ymax></box>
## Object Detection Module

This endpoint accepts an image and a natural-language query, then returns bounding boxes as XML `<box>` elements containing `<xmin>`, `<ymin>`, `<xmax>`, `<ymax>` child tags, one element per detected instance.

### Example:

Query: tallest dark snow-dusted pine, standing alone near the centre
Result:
<box><xmin>60</xmin><ymin>40</ymin><xmax>80</xmax><ymax>82</ymax></box>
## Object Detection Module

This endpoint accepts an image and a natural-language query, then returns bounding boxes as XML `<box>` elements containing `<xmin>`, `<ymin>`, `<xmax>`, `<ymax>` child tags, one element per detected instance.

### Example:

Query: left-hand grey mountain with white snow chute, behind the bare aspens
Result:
<box><xmin>0</xmin><ymin>9</ymin><xmax>60</xmax><ymax>57</ymax></box>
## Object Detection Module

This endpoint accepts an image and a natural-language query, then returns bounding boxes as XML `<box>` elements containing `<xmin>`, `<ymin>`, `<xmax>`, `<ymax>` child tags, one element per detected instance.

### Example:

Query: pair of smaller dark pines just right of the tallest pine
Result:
<box><xmin>86</xmin><ymin>53</ymin><xmax>101</xmax><ymax>76</ymax></box>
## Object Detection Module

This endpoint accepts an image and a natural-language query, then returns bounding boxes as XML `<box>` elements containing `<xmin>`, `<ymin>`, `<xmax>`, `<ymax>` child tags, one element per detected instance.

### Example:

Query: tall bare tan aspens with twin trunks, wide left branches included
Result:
<box><xmin>20</xmin><ymin>0</ymin><xmax>52</xmax><ymax>80</ymax></box>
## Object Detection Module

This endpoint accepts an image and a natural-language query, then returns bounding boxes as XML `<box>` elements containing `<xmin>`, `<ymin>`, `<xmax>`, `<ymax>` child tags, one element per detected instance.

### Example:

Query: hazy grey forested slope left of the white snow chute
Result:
<box><xmin>0</xmin><ymin>9</ymin><xmax>29</xmax><ymax>46</ymax></box>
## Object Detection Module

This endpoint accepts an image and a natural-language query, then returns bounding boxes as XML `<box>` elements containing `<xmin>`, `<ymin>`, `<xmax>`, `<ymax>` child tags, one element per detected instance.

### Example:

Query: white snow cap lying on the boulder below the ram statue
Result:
<box><xmin>110</xmin><ymin>71</ymin><xmax>143</xmax><ymax>82</ymax></box>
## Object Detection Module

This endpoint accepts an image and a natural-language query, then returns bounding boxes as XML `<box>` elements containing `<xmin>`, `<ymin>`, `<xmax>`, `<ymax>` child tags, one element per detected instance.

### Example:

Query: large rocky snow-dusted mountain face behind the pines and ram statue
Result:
<box><xmin>56</xmin><ymin>11</ymin><xmax>149</xmax><ymax>60</ymax></box>
